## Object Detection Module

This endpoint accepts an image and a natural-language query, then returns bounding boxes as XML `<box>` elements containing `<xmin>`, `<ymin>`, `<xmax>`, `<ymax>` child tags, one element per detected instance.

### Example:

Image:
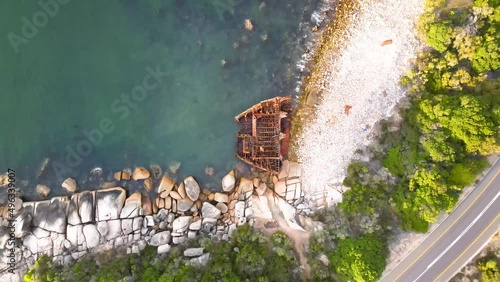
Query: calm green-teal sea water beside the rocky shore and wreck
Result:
<box><xmin>0</xmin><ymin>0</ymin><xmax>320</xmax><ymax>200</ymax></box>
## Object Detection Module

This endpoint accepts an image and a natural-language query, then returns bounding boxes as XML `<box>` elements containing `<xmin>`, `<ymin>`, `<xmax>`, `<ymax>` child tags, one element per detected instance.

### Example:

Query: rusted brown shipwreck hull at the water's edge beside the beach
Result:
<box><xmin>235</xmin><ymin>96</ymin><xmax>292</xmax><ymax>173</ymax></box>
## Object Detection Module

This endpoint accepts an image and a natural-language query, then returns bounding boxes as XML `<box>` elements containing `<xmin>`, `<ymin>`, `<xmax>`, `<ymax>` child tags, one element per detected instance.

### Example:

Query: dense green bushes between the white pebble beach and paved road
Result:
<box><xmin>309</xmin><ymin>0</ymin><xmax>500</xmax><ymax>281</ymax></box>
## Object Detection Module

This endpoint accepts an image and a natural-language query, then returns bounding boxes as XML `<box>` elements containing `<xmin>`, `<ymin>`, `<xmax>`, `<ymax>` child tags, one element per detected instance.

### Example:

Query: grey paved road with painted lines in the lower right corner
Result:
<box><xmin>380</xmin><ymin>159</ymin><xmax>500</xmax><ymax>282</ymax></box>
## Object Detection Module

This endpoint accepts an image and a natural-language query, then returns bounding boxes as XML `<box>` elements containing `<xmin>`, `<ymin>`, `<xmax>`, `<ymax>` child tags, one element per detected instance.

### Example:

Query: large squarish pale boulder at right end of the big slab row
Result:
<box><xmin>95</xmin><ymin>187</ymin><xmax>126</xmax><ymax>221</ymax></box>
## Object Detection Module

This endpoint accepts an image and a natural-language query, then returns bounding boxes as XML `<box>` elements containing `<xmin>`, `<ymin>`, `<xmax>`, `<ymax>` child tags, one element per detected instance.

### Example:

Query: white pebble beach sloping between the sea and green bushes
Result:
<box><xmin>298</xmin><ymin>0</ymin><xmax>423</xmax><ymax>206</ymax></box>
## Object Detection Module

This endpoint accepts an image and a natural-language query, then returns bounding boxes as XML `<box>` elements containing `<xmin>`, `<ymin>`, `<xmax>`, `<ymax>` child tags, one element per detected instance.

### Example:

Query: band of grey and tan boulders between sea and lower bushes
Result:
<box><xmin>0</xmin><ymin>161</ymin><xmax>311</xmax><ymax>281</ymax></box>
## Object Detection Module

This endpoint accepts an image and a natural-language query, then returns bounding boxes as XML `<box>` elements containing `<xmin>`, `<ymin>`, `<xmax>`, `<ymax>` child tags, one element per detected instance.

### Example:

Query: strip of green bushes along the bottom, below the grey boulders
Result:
<box><xmin>24</xmin><ymin>225</ymin><xmax>300</xmax><ymax>282</ymax></box>
